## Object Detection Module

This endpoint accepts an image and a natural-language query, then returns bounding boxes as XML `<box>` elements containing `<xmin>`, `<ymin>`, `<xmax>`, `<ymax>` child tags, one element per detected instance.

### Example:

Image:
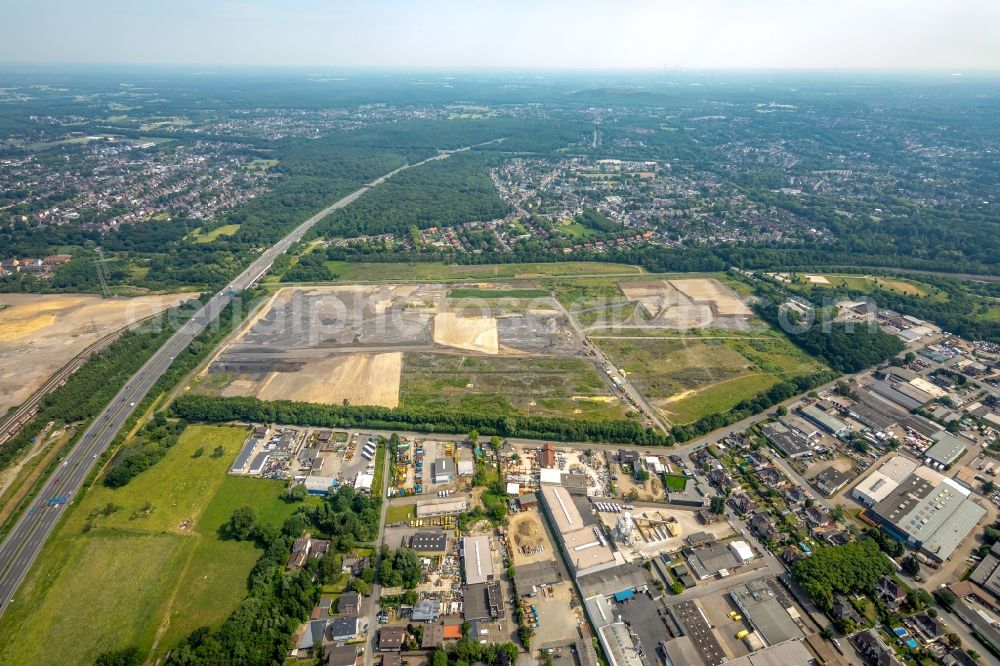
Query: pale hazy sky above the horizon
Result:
<box><xmin>0</xmin><ymin>0</ymin><xmax>1000</xmax><ymax>70</ymax></box>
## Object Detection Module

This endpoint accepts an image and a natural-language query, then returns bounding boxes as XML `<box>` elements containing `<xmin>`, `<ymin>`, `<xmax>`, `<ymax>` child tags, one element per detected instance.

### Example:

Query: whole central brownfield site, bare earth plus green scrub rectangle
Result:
<box><xmin>196</xmin><ymin>284</ymin><xmax>596</xmax><ymax>418</ymax></box>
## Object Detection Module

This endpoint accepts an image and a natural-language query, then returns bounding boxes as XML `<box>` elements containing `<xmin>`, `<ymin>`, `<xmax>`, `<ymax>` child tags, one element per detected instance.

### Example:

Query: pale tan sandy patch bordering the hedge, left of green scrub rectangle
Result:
<box><xmin>250</xmin><ymin>352</ymin><xmax>403</xmax><ymax>407</ymax></box>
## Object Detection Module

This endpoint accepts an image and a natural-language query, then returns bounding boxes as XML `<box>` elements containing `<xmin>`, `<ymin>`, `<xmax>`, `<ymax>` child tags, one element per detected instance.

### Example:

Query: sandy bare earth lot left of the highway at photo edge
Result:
<box><xmin>0</xmin><ymin>294</ymin><xmax>195</xmax><ymax>414</ymax></box>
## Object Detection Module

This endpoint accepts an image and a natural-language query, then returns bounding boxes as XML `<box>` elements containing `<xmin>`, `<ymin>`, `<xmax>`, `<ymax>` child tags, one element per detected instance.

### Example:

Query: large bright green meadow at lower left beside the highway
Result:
<box><xmin>0</xmin><ymin>426</ymin><xmax>295</xmax><ymax>664</ymax></box>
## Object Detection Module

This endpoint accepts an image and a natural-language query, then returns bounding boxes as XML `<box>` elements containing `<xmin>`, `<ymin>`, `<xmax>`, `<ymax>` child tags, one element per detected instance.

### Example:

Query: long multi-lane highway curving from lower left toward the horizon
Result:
<box><xmin>0</xmin><ymin>148</ymin><xmax>476</xmax><ymax>614</ymax></box>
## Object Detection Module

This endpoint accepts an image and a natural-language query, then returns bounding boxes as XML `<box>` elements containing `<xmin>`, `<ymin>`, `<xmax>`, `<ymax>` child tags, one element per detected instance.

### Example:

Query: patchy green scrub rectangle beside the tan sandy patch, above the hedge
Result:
<box><xmin>400</xmin><ymin>352</ymin><xmax>625</xmax><ymax>420</ymax></box>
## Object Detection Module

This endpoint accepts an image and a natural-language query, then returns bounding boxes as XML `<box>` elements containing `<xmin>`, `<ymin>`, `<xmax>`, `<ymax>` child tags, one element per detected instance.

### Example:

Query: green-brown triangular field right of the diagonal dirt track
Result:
<box><xmin>594</xmin><ymin>336</ymin><xmax>821</xmax><ymax>423</ymax></box>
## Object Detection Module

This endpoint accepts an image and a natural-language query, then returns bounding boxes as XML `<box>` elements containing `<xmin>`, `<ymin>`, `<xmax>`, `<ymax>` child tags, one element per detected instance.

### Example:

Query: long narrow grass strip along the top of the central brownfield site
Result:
<box><xmin>326</xmin><ymin>261</ymin><xmax>642</xmax><ymax>282</ymax></box>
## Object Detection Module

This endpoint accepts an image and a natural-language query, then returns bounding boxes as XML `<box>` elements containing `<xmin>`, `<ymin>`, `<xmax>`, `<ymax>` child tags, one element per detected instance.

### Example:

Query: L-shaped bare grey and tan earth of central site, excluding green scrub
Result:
<box><xmin>198</xmin><ymin>284</ymin><xmax>583</xmax><ymax>407</ymax></box>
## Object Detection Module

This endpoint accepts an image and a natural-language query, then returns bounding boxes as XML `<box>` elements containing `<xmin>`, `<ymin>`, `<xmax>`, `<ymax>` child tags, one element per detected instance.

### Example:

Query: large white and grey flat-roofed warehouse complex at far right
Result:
<box><xmin>851</xmin><ymin>456</ymin><xmax>986</xmax><ymax>562</ymax></box>
